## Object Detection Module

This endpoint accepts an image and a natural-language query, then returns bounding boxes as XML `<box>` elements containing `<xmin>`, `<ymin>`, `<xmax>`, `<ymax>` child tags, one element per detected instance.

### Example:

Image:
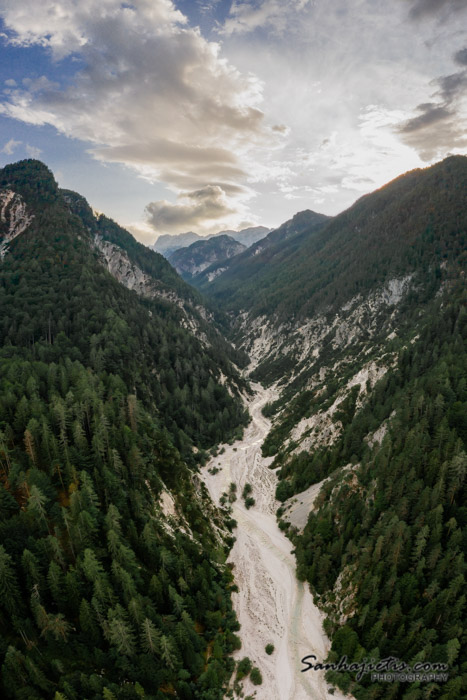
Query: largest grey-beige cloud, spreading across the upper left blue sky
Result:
<box><xmin>0</xmin><ymin>0</ymin><xmax>274</xmax><ymax>235</ymax></box>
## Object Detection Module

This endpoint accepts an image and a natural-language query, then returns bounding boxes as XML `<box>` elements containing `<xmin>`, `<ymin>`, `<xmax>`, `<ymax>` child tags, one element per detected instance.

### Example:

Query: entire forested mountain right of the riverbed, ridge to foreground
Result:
<box><xmin>198</xmin><ymin>156</ymin><xmax>467</xmax><ymax>700</ymax></box>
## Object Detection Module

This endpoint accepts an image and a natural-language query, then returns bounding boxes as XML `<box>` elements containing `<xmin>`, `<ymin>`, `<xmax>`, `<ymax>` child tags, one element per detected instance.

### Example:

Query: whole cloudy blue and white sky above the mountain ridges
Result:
<box><xmin>0</xmin><ymin>0</ymin><xmax>467</xmax><ymax>244</ymax></box>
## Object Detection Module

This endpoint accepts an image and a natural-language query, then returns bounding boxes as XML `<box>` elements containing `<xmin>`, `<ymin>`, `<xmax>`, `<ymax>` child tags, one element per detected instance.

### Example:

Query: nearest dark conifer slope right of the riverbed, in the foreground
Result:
<box><xmin>288</xmin><ymin>282</ymin><xmax>467</xmax><ymax>700</ymax></box>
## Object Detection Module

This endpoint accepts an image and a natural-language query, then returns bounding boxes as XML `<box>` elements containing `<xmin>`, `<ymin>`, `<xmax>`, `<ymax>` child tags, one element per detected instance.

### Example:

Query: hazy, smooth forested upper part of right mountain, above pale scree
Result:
<box><xmin>200</xmin><ymin>156</ymin><xmax>467</xmax><ymax>322</ymax></box>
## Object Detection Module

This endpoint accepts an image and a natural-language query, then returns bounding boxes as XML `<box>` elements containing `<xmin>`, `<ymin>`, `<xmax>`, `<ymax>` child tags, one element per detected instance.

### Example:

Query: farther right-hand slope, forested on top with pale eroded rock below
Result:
<box><xmin>214</xmin><ymin>156</ymin><xmax>467</xmax><ymax>446</ymax></box>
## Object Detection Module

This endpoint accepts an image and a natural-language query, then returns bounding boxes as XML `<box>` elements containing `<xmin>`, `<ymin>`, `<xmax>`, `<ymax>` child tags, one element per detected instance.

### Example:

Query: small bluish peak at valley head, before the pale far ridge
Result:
<box><xmin>168</xmin><ymin>235</ymin><xmax>246</xmax><ymax>280</ymax></box>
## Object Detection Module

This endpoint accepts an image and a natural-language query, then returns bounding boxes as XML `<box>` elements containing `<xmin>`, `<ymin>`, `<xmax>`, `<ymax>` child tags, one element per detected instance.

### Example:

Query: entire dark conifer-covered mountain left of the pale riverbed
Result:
<box><xmin>0</xmin><ymin>160</ymin><xmax>247</xmax><ymax>700</ymax></box>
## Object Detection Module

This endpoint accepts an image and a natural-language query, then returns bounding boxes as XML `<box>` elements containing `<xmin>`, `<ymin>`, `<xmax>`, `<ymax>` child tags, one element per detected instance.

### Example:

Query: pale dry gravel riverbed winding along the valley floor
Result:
<box><xmin>203</xmin><ymin>385</ymin><xmax>345</xmax><ymax>700</ymax></box>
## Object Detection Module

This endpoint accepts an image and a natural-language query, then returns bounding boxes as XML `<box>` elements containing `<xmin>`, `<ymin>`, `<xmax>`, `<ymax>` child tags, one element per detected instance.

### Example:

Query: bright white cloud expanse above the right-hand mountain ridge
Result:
<box><xmin>218</xmin><ymin>0</ymin><xmax>467</xmax><ymax>214</ymax></box>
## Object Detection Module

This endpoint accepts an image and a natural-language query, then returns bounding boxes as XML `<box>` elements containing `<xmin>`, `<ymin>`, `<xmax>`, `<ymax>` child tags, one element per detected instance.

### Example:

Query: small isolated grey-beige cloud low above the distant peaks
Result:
<box><xmin>146</xmin><ymin>185</ymin><xmax>239</xmax><ymax>233</ymax></box>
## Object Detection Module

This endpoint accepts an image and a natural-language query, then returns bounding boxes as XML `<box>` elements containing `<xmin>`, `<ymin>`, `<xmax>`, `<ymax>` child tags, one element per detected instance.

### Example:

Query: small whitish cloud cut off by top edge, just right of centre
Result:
<box><xmin>221</xmin><ymin>0</ymin><xmax>310</xmax><ymax>35</ymax></box>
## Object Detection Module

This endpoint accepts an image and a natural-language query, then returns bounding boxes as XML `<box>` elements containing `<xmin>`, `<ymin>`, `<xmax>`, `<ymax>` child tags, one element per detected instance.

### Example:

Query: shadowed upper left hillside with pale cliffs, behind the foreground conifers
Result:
<box><xmin>0</xmin><ymin>161</ymin><xmax>250</xmax><ymax>462</ymax></box>
